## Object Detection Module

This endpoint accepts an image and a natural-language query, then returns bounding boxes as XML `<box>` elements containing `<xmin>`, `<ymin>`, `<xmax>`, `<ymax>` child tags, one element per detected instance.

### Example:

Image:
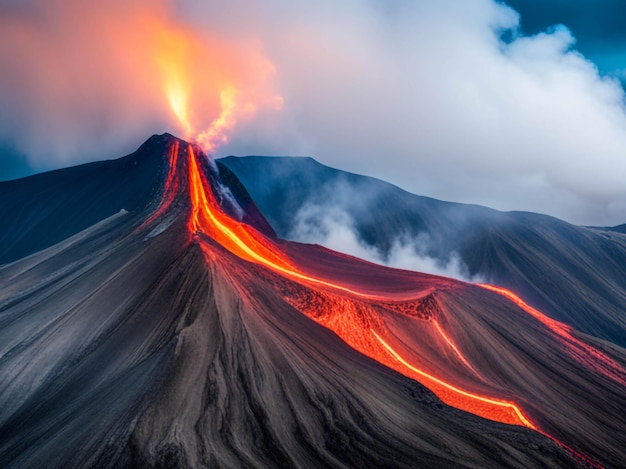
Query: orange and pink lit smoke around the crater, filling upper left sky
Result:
<box><xmin>0</xmin><ymin>0</ymin><xmax>280</xmax><ymax>169</ymax></box>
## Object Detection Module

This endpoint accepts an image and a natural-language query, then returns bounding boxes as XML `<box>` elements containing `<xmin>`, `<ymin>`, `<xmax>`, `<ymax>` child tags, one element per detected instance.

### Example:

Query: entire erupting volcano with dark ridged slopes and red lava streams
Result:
<box><xmin>0</xmin><ymin>134</ymin><xmax>626</xmax><ymax>468</ymax></box>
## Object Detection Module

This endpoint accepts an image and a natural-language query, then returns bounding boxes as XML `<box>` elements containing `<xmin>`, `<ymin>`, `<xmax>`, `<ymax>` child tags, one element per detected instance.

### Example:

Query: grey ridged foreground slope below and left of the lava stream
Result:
<box><xmin>0</xmin><ymin>135</ymin><xmax>584</xmax><ymax>468</ymax></box>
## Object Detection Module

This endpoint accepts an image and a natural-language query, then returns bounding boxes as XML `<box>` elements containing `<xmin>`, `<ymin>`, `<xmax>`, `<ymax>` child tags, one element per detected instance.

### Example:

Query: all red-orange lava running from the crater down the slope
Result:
<box><xmin>125</xmin><ymin>140</ymin><xmax>618</xmax><ymax>465</ymax></box>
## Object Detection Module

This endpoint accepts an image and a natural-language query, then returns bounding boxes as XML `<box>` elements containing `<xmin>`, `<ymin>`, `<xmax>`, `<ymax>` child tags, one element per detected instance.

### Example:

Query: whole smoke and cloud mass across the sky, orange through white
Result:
<box><xmin>0</xmin><ymin>0</ymin><xmax>626</xmax><ymax>225</ymax></box>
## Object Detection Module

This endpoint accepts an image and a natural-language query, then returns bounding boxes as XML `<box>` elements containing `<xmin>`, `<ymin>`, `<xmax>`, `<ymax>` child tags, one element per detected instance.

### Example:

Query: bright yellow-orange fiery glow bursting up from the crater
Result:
<box><xmin>156</xmin><ymin>19</ymin><xmax>282</xmax><ymax>155</ymax></box>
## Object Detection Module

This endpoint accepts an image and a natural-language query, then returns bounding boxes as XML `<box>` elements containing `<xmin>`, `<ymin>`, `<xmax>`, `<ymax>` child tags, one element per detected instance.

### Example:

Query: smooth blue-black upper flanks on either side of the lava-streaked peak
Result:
<box><xmin>0</xmin><ymin>135</ymin><xmax>274</xmax><ymax>265</ymax></box>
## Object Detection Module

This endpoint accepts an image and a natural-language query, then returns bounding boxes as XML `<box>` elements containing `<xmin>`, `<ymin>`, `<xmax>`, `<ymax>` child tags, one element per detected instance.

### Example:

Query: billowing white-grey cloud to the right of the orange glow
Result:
<box><xmin>217</xmin><ymin>0</ymin><xmax>626</xmax><ymax>224</ymax></box>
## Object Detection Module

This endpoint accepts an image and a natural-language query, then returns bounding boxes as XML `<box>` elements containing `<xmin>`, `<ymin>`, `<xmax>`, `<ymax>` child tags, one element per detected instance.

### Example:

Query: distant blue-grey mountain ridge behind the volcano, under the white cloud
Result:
<box><xmin>221</xmin><ymin>156</ymin><xmax>626</xmax><ymax>347</ymax></box>
